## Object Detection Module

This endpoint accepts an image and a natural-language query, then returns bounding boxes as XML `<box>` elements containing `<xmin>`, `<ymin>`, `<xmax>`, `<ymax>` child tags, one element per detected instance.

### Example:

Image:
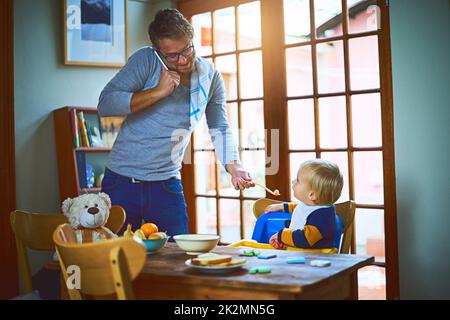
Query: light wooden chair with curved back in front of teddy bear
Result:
<box><xmin>53</xmin><ymin>224</ymin><xmax>147</xmax><ymax>300</ymax></box>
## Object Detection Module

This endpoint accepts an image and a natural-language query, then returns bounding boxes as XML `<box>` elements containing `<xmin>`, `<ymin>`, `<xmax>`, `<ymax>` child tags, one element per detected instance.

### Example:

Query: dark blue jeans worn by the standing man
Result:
<box><xmin>102</xmin><ymin>168</ymin><xmax>188</xmax><ymax>236</ymax></box>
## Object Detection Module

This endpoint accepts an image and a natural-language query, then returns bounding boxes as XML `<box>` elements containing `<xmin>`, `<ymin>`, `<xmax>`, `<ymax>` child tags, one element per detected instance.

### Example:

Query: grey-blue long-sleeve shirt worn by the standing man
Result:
<box><xmin>97</xmin><ymin>47</ymin><xmax>239</xmax><ymax>181</ymax></box>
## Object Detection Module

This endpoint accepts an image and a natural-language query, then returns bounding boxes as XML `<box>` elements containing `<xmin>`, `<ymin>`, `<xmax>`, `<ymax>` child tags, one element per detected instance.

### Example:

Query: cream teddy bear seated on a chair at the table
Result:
<box><xmin>62</xmin><ymin>192</ymin><xmax>117</xmax><ymax>243</ymax></box>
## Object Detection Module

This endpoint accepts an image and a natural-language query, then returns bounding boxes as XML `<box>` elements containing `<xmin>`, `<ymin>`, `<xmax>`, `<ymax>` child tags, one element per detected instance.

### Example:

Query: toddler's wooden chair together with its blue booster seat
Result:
<box><xmin>231</xmin><ymin>198</ymin><xmax>356</xmax><ymax>253</ymax></box>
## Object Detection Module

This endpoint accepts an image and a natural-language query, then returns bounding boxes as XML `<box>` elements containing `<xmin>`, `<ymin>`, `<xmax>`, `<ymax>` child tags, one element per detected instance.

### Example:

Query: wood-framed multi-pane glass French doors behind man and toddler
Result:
<box><xmin>179</xmin><ymin>0</ymin><xmax>398</xmax><ymax>298</ymax></box>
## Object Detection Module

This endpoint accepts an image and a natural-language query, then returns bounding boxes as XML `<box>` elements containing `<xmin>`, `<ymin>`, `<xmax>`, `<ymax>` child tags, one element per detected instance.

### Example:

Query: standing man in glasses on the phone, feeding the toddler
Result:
<box><xmin>98</xmin><ymin>9</ymin><xmax>254</xmax><ymax>236</ymax></box>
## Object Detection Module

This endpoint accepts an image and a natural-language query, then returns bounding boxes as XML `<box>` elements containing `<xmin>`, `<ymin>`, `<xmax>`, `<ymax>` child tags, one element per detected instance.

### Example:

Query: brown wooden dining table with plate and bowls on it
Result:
<box><xmin>133</xmin><ymin>243</ymin><xmax>374</xmax><ymax>300</ymax></box>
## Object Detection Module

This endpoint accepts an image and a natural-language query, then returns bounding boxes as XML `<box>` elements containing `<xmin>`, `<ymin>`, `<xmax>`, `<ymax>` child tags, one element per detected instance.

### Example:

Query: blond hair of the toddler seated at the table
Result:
<box><xmin>298</xmin><ymin>159</ymin><xmax>344</xmax><ymax>205</ymax></box>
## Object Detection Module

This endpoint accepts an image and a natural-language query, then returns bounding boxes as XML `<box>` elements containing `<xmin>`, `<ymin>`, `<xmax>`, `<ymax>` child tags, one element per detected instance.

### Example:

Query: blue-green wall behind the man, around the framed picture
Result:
<box><xmin>14</xmin><ymin>0</ymin><xmax>168</xmax><ymax>278</ymax></box>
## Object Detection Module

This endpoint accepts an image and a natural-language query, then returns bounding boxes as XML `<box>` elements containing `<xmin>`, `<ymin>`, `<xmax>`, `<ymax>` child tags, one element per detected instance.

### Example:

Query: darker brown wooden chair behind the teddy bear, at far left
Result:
<box><xmin>10</xmin><ymin>206</ymin><xmax>126</xmax><ymax>294</ymax></box>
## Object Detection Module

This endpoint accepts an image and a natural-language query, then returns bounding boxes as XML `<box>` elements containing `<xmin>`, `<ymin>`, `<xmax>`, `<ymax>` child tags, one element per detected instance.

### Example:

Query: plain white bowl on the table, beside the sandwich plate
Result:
<box><xmin>173</xmin><ymin>234</ymin><xmax>220</xmax><ymax>254</ymax></box>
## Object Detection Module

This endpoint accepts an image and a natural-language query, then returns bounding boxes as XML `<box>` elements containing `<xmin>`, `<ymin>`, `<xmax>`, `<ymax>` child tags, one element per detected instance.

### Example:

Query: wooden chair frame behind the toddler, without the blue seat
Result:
<box><xmin>253</xmin><ymin>198</ymin><xmax>356</xmax><ymax>253</ymax></box>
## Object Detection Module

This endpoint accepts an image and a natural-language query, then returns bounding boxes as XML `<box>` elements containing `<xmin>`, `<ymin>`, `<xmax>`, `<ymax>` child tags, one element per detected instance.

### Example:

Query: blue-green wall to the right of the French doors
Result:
<box><xmin>390</xmin><ymin>0</ymin><xmax>450</xmax><ymax>299</ymax></box>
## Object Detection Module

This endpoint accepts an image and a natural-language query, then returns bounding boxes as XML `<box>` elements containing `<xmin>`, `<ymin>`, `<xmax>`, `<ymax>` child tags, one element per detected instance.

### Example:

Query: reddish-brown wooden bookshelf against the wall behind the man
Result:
<box><xmin>53</xmin><ymin>106</ymin><xmax>123</xmax><ymax>202</ymax></box>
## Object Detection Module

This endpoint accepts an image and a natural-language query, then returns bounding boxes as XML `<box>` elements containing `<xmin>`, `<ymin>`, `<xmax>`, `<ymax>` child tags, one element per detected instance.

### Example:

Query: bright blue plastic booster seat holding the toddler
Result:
<box><xmin>252</xmin><ymin>212</ymin><xmax>343</xmax><ymax>249</ymax></box>
